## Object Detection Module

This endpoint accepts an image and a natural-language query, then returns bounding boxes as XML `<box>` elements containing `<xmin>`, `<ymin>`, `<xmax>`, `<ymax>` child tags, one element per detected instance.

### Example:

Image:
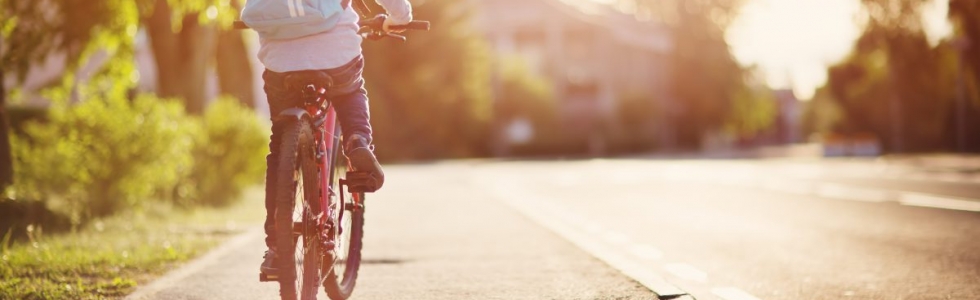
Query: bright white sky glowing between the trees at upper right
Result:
<box><xmin>726</xmin><ymin>0</ymin><xmax>952</xmax><ymax>99</ymax></box>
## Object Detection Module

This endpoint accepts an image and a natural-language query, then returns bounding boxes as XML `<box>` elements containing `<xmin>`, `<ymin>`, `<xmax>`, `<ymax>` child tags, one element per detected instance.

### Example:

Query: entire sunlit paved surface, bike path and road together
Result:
<box><xmin>126</xmin><ymin>159</ymin><xmax>980</xmax><ymax>300</ymax></box>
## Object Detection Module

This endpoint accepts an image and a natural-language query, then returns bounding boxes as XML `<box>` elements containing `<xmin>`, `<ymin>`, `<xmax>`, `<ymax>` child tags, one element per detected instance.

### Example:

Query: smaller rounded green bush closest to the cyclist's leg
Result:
<box><xmin>178</xmin><ymin>98</ymin><xmax>270</xmax><ymax>206</ymax></box>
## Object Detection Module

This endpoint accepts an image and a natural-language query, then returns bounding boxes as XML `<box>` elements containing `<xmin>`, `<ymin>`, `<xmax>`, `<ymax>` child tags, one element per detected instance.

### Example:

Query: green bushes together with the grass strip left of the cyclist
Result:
<box><xmin>0</xmin><ymin>86</ymin><xmax>268</xmax><ymax>299</ymax></box>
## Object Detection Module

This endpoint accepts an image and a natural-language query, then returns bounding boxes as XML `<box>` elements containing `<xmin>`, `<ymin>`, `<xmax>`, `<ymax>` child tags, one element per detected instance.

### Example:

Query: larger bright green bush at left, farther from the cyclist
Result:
<box><xmin>12</xmin><ymin>96</ymin><xmax>196</xmax><ymax>224</ymax></box>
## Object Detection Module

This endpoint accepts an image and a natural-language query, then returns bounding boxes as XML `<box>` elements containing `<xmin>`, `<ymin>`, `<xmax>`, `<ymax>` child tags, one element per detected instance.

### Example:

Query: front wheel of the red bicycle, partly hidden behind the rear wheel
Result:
<box><xmin>322</xmin><ymin>127</ymin><xmax>365</xmax><ymax>300</ymax></box>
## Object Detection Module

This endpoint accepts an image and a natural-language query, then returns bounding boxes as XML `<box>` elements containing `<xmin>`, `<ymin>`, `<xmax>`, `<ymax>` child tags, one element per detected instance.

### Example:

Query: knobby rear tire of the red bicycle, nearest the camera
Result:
<box><xmin>275</xmin><ymin>119</ymin><xmax>323</xmax><ymax>300</ymax></box>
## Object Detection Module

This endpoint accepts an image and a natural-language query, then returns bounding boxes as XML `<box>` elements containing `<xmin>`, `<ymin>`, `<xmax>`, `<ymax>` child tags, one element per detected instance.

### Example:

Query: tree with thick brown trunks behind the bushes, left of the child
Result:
<box><xmin>142</xmin><ymin>0</ymin><xmax>255</xmax><ymax>114</ymax></box>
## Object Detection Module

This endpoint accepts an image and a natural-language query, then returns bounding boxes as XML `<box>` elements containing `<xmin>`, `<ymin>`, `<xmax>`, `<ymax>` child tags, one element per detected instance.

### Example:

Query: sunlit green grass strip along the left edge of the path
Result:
<box><xmin>0</xmin><ymin>189</ymin><xmax>265</xmax><ymax>299</ymax></box>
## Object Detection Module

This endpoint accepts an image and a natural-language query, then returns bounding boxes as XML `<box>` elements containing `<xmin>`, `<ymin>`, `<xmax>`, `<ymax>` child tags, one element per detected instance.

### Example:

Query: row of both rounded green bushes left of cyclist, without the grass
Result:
<box><xmin>6</xmin><ymin>92</ymin><xmax>269</xmax><ymax>229</ymax></box>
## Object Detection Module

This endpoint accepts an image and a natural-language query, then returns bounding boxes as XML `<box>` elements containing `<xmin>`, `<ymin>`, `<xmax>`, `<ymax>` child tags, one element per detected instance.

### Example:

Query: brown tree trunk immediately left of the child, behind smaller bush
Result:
<box><xmin>215</xmin><ymin>1</ymin><xmax>255</xmax><ymax>108</ymax></box>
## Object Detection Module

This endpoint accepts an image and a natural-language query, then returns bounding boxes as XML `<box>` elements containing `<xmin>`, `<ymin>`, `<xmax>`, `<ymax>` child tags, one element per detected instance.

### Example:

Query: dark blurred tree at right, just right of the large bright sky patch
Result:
<box><xmin>827</xmin><ymin>0</ymin><xmax>956</xmax><ymax>152</ymax></box>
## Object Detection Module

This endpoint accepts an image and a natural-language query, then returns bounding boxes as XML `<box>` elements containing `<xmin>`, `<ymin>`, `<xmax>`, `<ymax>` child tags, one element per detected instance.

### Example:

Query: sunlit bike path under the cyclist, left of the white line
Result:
<box><xmin>124</xmin><ymin>165</ymin><xmax>656</xmax><ymax>300</ymax></box>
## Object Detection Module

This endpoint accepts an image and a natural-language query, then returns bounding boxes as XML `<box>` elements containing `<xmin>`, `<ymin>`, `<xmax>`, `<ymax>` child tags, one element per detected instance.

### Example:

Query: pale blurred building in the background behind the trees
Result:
<box><xmin>471</xmin><ymin>0</ymin><xmax>672</xmax><ymax>152</ymax></box>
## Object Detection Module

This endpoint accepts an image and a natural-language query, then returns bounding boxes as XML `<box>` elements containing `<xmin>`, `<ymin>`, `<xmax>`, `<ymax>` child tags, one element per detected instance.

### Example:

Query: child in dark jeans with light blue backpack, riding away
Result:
<box><xmin>242</xmin><ymin>0</ymin><xmax>412</xmax><ymax>274</ymax></box>
